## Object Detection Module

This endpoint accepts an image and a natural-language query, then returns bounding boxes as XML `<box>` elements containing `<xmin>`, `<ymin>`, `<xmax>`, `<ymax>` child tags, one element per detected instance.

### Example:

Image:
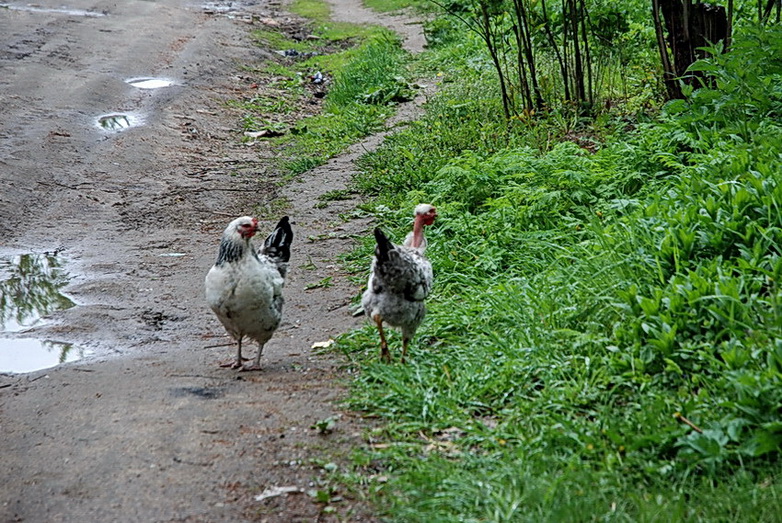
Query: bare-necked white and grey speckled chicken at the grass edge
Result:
<box><xmin>361</xmin><ymin>203</ymin><xmax>437</xmax><ymax>363</ymax></box>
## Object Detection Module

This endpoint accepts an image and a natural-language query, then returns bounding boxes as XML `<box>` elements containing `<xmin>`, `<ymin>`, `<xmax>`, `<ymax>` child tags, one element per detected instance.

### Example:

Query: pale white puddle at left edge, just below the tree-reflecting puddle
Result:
<box><xmin>0</xmin><ymin>338</ymin><xmax>89</xmax><ymax>373</ymax></box>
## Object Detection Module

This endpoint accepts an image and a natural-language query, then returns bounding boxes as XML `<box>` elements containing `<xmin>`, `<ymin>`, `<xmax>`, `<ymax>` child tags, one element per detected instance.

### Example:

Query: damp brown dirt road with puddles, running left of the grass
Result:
<box><xmin>0</xmin><ymin>0</ymin><xmax>423</xmax><ymax>522</ymax></box>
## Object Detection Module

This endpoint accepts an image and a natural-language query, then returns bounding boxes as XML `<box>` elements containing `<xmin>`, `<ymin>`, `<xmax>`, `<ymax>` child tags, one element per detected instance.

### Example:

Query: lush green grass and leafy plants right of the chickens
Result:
<box><xmin>338</xmin><ymin>19</ymin><xmax>782</xmax><ymax>522</ymax></box>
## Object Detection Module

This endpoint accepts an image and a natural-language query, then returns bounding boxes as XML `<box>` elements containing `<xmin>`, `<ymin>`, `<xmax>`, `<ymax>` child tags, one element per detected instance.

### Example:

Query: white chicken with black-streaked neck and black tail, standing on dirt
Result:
<box><xmin>205</xmin><ymin>216</ymin><xmax>293</xmax><ymax>370</ymax></box>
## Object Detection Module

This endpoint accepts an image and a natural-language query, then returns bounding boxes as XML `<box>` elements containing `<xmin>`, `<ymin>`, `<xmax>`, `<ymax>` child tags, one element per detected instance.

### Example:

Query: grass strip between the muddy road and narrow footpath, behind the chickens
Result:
<box><xmin>232</xmin><ymin>0</ymin><xmax>412</xmax><ymax>175</ymax></box>
